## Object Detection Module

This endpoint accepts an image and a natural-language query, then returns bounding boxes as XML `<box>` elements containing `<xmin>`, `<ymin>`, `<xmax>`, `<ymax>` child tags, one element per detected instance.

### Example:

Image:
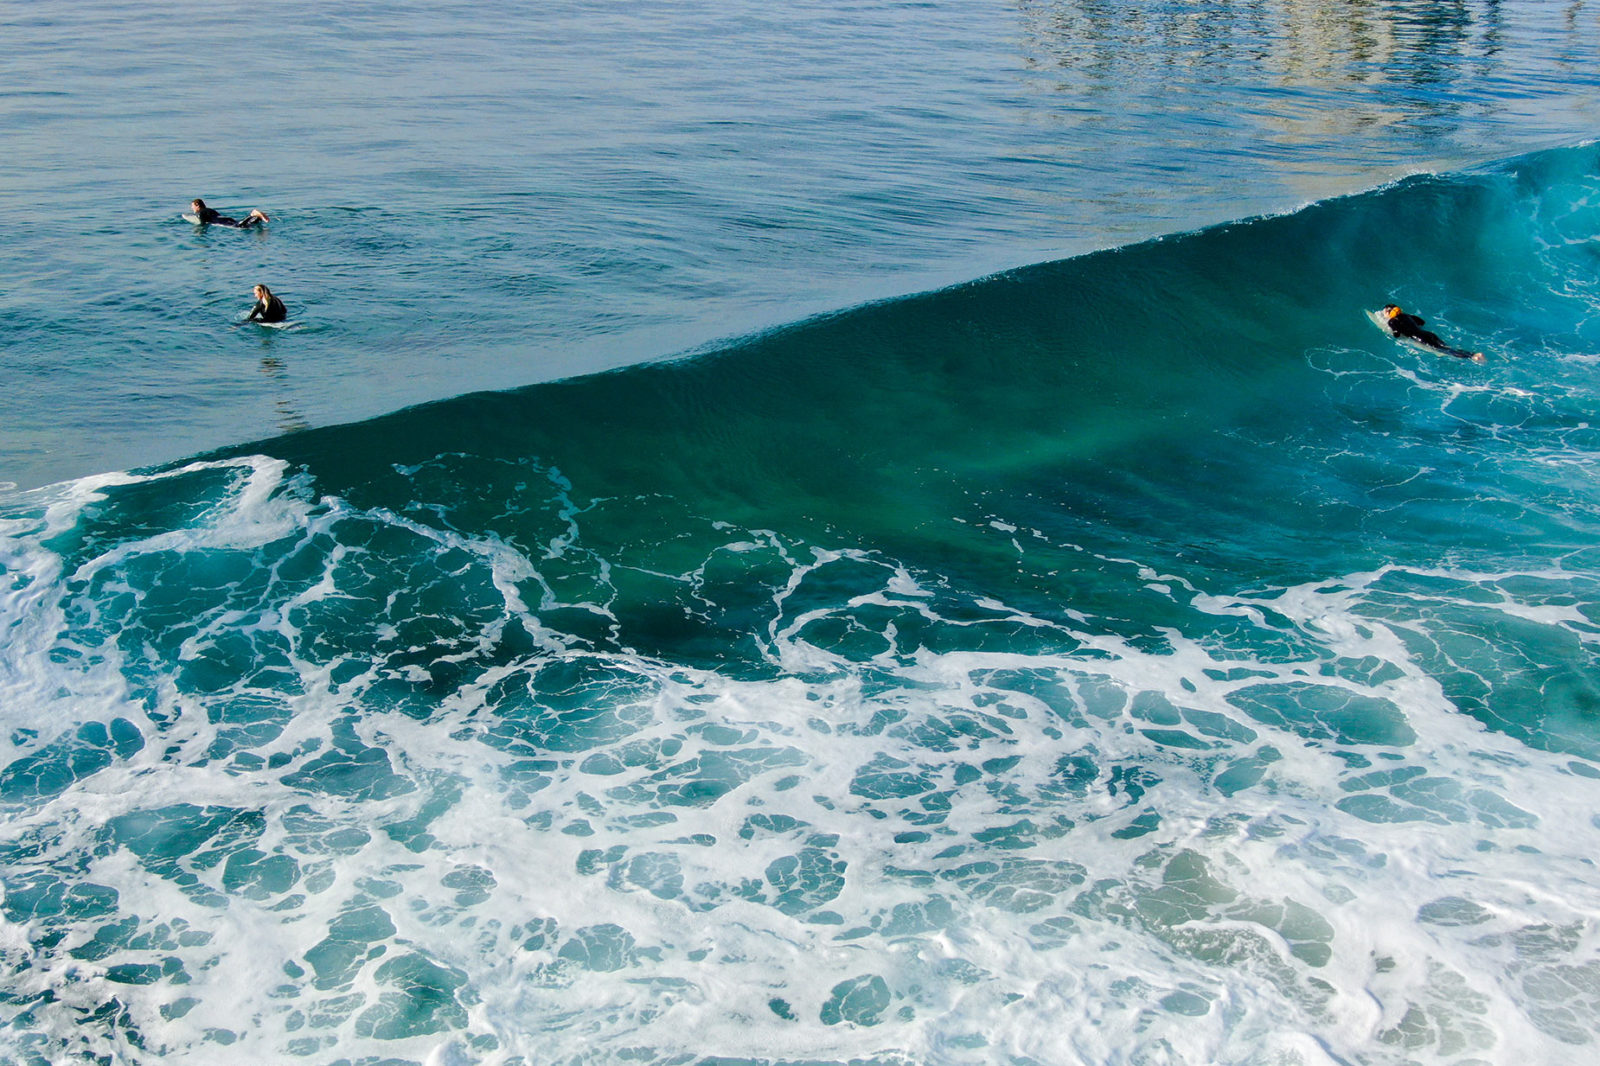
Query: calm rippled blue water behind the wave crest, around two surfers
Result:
<box><xmin>0</xmin><ymin>0</ymin><xmax>1600</xmax><ymax>488</ymax></box>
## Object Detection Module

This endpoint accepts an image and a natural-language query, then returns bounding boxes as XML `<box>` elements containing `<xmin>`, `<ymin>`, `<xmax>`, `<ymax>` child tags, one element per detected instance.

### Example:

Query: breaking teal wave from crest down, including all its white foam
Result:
<box><xmin>0</xmin><ymin>146</ymin><xmax>1600</xmax><ymax>1063</ymax></box>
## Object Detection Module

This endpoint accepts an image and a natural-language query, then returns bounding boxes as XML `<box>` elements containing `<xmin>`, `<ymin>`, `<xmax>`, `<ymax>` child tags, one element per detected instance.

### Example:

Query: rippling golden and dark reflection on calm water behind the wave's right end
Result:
<box><xmin>1018</xmin><ymin>0</ymin><xmax>1600</xmax><ymax>197</ymax></box>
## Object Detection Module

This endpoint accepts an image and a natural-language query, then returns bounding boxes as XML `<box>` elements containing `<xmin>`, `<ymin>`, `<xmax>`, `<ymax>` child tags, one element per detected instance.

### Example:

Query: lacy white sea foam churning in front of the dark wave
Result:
<box><xmin>0</xmin><ymin>461</ymin><xmax>1600</xmax><ymax>1064</ymax></box>
